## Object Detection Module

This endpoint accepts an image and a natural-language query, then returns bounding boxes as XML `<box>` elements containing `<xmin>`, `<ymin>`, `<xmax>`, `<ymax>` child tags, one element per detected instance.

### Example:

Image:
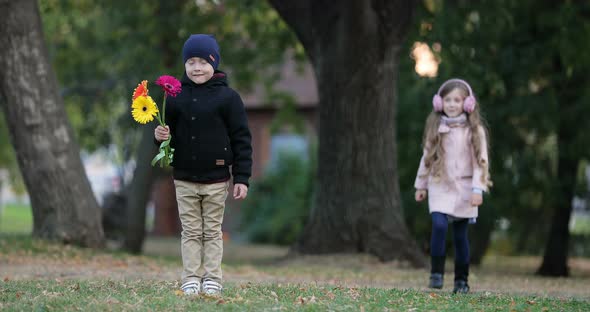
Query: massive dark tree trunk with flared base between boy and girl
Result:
<box><xmin>270</xmin><ymin>0</ymin><xmax>425</xmax><ymax>266</ymax></box>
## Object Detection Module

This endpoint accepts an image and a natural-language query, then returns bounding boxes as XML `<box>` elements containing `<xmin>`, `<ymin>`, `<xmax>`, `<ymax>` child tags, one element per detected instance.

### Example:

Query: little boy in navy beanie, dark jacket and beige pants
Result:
<box><xmin>155</xmin><ymin>34</ymin><xmax>252</xmax><ymax>296</ymax></box>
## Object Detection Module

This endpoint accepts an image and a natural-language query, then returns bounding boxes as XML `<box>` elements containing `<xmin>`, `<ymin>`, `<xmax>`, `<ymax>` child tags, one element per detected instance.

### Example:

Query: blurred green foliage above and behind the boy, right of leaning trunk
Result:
<box><xmin>31</xmin><ymin>0</ymin><xmax>303</xmax><ymax>160</ymax></box>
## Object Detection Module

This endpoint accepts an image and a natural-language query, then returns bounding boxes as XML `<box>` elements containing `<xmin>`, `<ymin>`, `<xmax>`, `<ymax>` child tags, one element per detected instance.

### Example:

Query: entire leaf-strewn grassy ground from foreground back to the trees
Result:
<box><xmin>0</xmin><ymin>234</ymin><xmax>590</xmax><ymax>311</ymax></box>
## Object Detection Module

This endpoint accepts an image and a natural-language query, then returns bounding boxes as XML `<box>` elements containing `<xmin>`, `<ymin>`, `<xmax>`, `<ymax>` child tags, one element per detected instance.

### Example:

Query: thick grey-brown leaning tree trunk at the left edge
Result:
<box><xmin>0</xmin><ymin>0</ymin><xmax>104</xmax><ymax>247</ymax></box>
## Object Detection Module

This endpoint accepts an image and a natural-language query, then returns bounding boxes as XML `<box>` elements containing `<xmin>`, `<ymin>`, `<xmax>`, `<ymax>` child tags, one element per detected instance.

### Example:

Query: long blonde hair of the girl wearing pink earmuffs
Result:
<box><xmin>422</xmin><ymin>82</ymin><xmax>492</xmax><ymax>186</ymax></box>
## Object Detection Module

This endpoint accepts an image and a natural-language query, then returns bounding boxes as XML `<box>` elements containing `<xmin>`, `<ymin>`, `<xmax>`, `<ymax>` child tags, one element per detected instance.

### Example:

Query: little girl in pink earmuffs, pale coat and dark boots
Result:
<box><xmin>414</xmin><ymin>79</ymin><xmax>492</xmax><ymax>293</ymax></box>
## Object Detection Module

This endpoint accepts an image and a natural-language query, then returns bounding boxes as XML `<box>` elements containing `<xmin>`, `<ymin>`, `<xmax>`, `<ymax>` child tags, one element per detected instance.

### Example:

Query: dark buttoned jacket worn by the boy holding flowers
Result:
<box><xmin>160</xmin><ymin>71</ymin><xmax>252</xmax><ymax>185</ymax></box>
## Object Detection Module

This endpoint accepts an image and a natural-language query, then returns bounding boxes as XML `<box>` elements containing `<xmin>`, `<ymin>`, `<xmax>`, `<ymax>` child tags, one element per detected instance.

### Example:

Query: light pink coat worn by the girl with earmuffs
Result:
<box><xmin>414</xmin><ymin>124</ymin><xmax>488</xmax><ymax>218</ymax></box>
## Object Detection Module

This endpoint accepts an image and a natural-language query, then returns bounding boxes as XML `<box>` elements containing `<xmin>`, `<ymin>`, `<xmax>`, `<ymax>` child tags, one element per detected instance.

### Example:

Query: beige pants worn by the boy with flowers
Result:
<box><xmin>174</xmin><ymin>180</ymin><xmax>229</xmax><ymax>284</ymax></box>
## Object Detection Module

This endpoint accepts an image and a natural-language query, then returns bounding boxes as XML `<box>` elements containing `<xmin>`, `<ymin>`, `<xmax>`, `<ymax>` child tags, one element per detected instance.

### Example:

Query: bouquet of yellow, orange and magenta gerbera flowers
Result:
<box><xmin>131</xmin><ymin>75</ymin><xmax>181</xmax><ymax>167</ymax></box>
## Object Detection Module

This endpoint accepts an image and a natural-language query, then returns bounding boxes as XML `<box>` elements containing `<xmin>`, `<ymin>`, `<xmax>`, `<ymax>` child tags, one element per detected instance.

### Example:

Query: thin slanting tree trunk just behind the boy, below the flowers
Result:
<box><xmin>123</xmin><ymin>123</ymin><xmax>158</xmax><ymax>254</ymax></box>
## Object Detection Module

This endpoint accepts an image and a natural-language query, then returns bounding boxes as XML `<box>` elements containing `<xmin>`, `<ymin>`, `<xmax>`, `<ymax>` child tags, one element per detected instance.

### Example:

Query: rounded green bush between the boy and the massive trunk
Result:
<box><xmin>241</xmin><ymin>149</ymin><xmax>315</xmax><ymax>245</ymax></box>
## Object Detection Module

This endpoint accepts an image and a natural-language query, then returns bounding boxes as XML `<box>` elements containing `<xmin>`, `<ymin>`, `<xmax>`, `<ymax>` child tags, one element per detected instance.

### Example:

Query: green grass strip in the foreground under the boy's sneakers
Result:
<box><xmin>0</xmin><ymin>280</ymin><xmax>590</xmax><ymax>311</ymax></box>
